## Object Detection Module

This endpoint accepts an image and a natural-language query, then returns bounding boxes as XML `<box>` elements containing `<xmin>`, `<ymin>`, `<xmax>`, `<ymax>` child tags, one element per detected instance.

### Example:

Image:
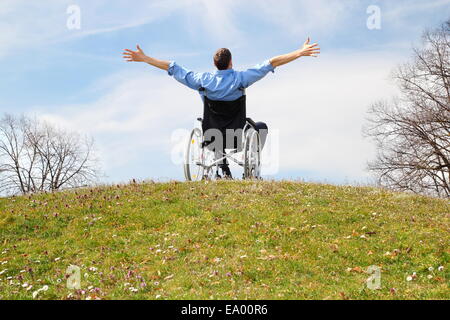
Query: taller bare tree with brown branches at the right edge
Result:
<box><xmin>365</xmin><ymin>20</ymin><xmax>450</xmax><ymax>197</ymax></box>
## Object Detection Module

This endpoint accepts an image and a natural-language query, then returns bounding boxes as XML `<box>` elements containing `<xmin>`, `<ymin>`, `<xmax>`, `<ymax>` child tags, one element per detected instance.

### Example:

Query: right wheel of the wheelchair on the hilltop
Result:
<box><xmin>244</xmin><ymin>130</ymin><xmax>261</xmax><ymax>179</ymax></box>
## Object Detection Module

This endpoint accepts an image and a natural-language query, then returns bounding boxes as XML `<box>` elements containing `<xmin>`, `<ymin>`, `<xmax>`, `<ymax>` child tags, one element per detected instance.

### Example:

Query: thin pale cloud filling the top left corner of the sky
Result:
<box><xmin>0</xmin><ymin>0</ymin><xmax>193</xmax><ymax>58</ymax></box>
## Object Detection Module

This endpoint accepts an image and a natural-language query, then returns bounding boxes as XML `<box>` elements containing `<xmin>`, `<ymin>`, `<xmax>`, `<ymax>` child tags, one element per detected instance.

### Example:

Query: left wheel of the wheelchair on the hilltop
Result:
<box><xmin>184</xmin><ymin>128</ymin><xmax>205</xmax><ymax>181</ymax></box>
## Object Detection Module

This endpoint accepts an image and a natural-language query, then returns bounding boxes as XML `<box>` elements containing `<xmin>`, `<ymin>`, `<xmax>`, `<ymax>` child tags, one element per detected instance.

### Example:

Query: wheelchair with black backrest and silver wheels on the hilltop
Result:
<box><xmin>184</xmin><ymin>92</ymin><xmax>262</xmax><ymax>181</ymax></box>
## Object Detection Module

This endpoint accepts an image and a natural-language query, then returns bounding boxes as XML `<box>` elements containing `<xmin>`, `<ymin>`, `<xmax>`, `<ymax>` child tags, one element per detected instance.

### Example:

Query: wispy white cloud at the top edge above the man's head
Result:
<box><xmin>179</xmin><ymin>0</ymin><xmax>357</xmax><ymax>47</ymax></box>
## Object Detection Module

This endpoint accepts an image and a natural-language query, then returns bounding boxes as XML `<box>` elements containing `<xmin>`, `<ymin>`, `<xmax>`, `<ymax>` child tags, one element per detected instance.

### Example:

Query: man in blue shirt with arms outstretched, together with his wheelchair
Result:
<box><xmin>123</xmin><ymin>38</ymin><xmax>320</xmax><ymax>180</ymax></box>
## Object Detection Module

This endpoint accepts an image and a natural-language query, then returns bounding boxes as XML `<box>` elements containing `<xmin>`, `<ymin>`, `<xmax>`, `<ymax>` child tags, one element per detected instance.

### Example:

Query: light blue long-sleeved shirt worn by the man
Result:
<box><xmin>168</xmin><ymin>60</ymin><xmax>275</xmax><ymax>101</ymax></box>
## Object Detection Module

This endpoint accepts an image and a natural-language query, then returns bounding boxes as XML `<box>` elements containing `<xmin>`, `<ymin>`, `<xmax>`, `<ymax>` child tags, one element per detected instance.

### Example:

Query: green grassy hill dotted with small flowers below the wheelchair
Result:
<box><xmin>0</xmin><ymin>182</ymin><xmax>450</xmax><ymax>299</ymax></box>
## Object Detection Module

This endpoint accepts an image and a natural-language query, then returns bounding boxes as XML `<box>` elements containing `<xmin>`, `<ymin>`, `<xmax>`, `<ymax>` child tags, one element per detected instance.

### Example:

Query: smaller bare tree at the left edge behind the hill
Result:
<box><xmin>0</xmin><ymin>114</ymin><xmax>99</xmax><ymax>194</ymax></box>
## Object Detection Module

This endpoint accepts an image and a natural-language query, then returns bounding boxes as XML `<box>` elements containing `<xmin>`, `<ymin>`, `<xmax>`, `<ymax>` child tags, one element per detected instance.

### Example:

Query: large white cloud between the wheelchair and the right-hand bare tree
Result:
<box><xmin>248</xmin><ymin>52</ymin><xmax>400</xmax><ymax>180</ymax></box>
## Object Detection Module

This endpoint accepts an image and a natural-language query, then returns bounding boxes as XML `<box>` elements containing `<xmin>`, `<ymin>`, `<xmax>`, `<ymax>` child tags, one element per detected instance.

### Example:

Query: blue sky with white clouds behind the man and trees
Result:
<box><xmin>0</xmin><ymin>0</ymin><xmax>450</xmax><ymax>183</ymax></box>
